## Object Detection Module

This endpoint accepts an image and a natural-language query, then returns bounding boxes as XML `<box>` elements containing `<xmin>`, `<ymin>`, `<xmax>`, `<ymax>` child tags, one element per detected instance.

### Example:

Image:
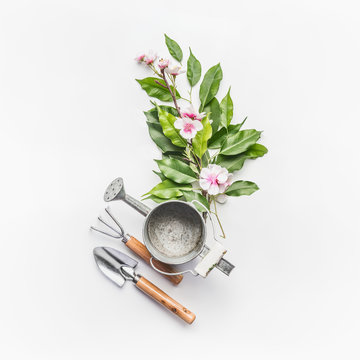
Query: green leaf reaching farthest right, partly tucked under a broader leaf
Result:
<box><xmin>216</xmin><ymin>144</ymin><xmax>268</xmax><ymax>172</ymax></box>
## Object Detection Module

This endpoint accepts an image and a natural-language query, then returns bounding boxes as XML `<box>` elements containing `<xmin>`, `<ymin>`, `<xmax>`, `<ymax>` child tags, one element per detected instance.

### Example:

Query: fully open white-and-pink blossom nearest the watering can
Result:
<box><xmin>199</xmin><ymin>164</ymin><xmax>232</xmax><ymax>195</ymax></box>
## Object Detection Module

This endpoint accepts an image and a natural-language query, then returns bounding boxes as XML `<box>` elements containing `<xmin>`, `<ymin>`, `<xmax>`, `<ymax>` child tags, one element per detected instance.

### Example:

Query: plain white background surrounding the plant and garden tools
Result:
<box><xmin>0</xmin><ymin>0</ymin><xmax>360</xmax><ymax>360</ymax></box>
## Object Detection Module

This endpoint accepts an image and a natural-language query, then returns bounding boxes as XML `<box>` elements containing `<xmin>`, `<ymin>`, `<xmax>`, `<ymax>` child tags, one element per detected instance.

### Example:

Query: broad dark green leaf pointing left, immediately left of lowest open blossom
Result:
<box><xmin>155</xmin><ymin>158</ymin><xmax>197</xmax><ymax>184</ymax></box>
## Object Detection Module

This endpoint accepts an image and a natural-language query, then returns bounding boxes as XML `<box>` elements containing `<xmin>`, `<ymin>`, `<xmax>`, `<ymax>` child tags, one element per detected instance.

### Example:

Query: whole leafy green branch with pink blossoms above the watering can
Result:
<box><xmin>136</xmin><ymin>35</ymin><xmax>267</xmax><ymax>237</ymax></box>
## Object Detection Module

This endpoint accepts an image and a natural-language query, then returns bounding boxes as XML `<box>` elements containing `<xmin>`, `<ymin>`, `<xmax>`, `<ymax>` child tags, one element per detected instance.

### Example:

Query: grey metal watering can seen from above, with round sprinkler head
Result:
<box><xmin>104</xmin><ymin>178</ymin><xmax>234</xmax><ymax>277</ymax></box>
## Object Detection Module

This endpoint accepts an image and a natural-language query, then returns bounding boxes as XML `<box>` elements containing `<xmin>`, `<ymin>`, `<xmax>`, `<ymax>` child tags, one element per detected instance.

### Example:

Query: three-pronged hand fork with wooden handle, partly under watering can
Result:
<box><xmin>90</xmin><ymin>208</ymin><xmax>183</xmax><ymax>285</ymax></box>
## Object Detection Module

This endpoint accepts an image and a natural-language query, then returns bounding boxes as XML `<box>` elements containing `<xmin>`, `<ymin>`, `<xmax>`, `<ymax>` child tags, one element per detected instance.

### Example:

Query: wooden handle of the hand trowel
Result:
<box><xmin>136</xmin><ymin>276</ymin><xmax>196</xmax><ymax>324</ymax></box>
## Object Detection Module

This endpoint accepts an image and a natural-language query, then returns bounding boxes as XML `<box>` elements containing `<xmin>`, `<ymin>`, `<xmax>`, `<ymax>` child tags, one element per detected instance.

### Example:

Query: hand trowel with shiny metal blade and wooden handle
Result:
<box><xmin>93</xmin><ymin>247</ymin><xmax>195</xmax><ymax>324</ymax></box>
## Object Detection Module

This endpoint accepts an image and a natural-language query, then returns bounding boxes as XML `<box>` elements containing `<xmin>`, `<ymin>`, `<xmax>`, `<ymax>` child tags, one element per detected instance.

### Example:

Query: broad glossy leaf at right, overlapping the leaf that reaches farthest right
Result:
<box><xmin>220</xmin><ymin>129</ymin><xmax>261</xmax><ymax>155</ymax></box>
